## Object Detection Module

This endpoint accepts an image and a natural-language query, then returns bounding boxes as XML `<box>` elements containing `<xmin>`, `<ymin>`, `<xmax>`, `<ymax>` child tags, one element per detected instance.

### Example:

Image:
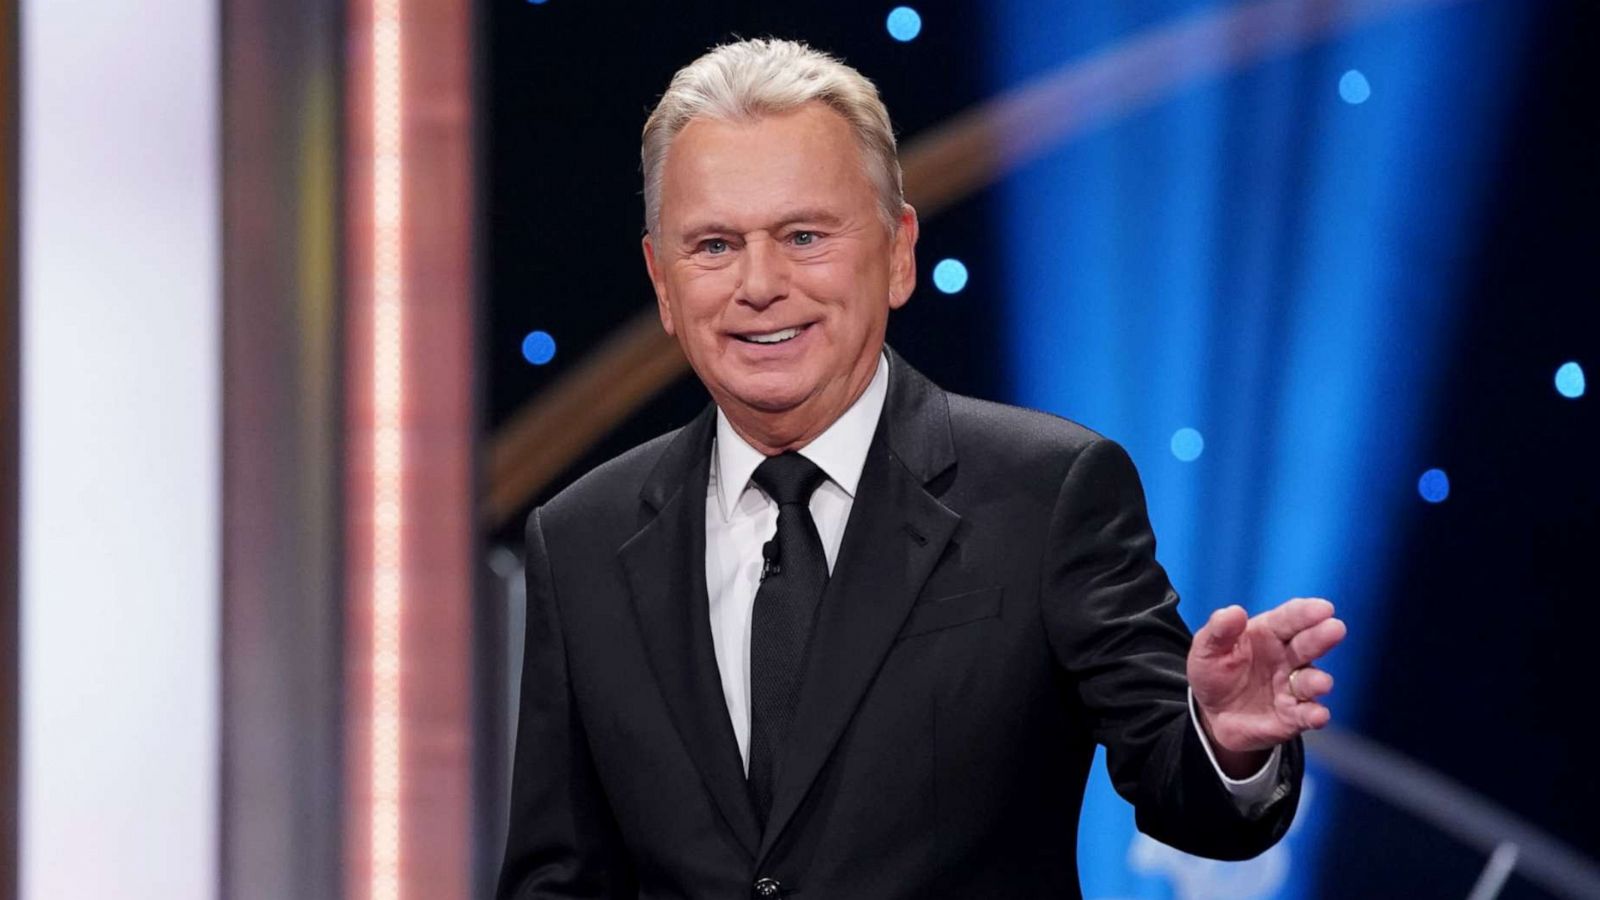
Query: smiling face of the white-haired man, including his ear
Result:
<box><xmin>645</xmin><ymin>102</ymin><xmax>917</xmax><ymax>437</ymax></box>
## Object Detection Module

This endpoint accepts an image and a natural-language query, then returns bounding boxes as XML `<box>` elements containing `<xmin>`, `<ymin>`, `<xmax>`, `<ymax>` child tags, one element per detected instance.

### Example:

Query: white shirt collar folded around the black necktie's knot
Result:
<box><xmin>712</xmin><ymin>354</ymin><xmax>890</xmax><ymax>520</ymax></box>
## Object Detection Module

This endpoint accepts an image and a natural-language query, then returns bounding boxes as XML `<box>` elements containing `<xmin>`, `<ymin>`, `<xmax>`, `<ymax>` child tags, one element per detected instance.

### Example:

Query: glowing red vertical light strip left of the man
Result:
<box><xmin>344</xmin><ymin>0</ymin><xmax>475</xmax><ymax>900</ymax></box>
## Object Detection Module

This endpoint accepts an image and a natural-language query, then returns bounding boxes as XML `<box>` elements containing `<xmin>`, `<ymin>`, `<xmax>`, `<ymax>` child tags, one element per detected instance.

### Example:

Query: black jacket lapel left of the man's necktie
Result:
<box><xmin>618</xmin><ymin>407</ymin><xmax>760</xmax><ymax>857</ymax></box>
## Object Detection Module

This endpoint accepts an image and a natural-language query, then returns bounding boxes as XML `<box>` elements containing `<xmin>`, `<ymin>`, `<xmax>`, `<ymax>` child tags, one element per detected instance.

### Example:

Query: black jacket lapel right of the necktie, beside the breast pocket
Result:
<box><xmin>757</xmin><ymin>351</ymin><xmax>960</xmax><ymax>862</ymax></box>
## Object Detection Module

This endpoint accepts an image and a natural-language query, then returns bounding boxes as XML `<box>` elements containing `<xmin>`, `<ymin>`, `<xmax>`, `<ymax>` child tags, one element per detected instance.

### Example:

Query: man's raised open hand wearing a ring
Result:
<box><xmin>1189</xmin><ymin>597</ymin><xmax>1346</xmax><ymax>753</ymax></box>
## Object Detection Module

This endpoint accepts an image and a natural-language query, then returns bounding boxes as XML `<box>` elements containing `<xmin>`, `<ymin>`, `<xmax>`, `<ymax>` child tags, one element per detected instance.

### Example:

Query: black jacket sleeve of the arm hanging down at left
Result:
<box><xmin>496</xmin><ymin>509</ymin><xmax>637</xmax><ymax>900</ymax></box>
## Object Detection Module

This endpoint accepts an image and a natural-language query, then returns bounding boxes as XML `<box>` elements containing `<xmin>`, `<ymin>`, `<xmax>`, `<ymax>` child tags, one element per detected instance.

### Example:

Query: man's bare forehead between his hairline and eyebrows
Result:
<box><xmin>661</xmin><ymin>102</ymin><xmax>877</xmax><ymax>221</ymax></box>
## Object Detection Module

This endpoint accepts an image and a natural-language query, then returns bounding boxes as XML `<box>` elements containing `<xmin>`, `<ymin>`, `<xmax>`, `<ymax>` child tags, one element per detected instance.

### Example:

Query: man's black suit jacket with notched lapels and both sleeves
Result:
<box><xmin>499</xmin><ymin>354</ymin><xmax>1302</xmax><ymax>900</ymax></box>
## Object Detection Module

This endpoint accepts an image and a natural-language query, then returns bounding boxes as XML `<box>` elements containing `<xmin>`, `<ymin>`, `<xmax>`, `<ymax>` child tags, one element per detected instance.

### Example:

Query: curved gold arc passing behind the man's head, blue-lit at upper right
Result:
<box><xmin>485</xmin><ymin>0</ymin><xmax>1461</xmax><ymax>525</ymax></box>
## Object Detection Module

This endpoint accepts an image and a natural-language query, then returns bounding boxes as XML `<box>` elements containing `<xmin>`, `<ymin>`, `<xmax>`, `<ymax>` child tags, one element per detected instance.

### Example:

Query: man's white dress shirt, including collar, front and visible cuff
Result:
<box><xmin>706</xmin><ymin>349</ymin><xmax>1286</xmax><ymax>810</ymax></box>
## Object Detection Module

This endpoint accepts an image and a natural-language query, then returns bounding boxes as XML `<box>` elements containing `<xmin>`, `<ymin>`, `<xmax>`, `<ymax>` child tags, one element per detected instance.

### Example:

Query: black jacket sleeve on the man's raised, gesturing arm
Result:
<box><xmin>1040</xmin><ymin>439</ymin><xmax>1304</xmax><ymax>860</ymax></box>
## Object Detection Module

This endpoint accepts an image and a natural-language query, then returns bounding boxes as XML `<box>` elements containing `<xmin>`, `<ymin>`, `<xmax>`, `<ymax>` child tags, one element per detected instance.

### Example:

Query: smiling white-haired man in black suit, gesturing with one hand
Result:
<box><xmin>499</xmin><ymin>40</ymin><xmax>1344</xmax><ymax>900</ymax></box>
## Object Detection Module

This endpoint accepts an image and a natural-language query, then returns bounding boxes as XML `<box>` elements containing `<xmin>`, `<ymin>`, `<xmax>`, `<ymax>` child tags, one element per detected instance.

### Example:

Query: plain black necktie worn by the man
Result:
<box><xmin>750</xmin><ymin>452</ymin><xmax>827</xmax><ymax>823</ymax></box>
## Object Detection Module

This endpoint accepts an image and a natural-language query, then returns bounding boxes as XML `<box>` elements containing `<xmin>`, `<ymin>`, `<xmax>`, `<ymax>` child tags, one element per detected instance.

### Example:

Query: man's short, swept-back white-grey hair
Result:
<box><xmin>640</xmin><ymin>38</ymin><xmax>904</xmax><ymax>232</ymax></box>
